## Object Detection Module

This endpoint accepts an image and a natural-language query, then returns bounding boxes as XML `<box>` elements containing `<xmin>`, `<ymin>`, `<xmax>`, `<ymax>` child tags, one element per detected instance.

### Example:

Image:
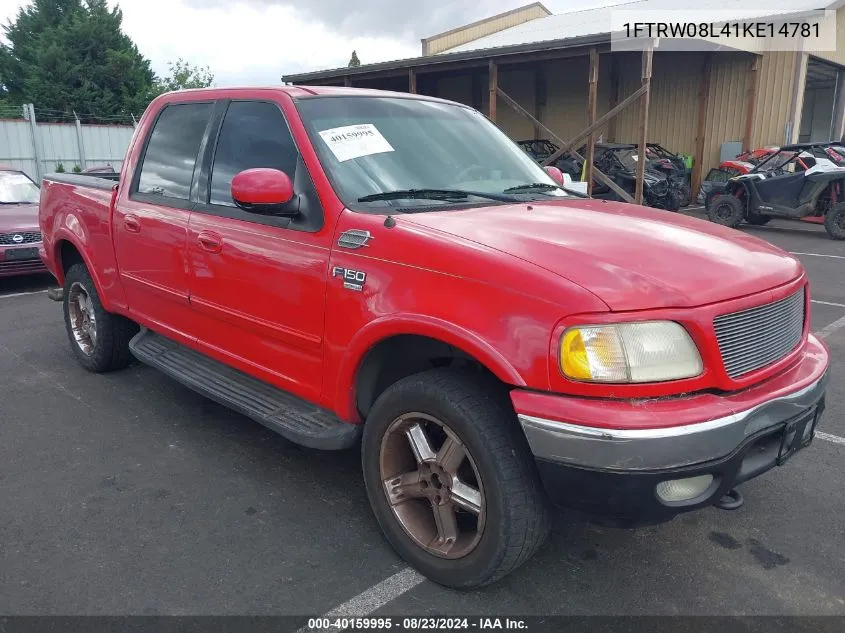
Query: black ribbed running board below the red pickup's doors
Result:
<box><xmin>129</xmin><ymin>329</ymin><xmax>361</xmax><ymax>450</ymax></box>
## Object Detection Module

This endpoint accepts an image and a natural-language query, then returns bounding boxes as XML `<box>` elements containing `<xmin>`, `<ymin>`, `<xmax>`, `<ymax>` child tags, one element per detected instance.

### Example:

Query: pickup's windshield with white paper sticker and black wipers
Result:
<box><xmin>297</xmin><ymin>97</ymin><xmax>566</xmax><ymax>211</ymax></box>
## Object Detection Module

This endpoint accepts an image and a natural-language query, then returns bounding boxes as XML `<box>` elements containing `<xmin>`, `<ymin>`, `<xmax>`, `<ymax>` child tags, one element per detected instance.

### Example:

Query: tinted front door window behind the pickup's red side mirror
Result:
<box><xmin>210</xmin><ymin>101</ymin><xmax>299</xmax><ymax>206</ymax></box>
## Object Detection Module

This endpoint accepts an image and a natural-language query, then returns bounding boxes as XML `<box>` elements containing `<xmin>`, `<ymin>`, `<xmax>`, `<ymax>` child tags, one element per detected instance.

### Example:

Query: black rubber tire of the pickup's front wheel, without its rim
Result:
<box><xmin>361</xmin><ymin>368</ymin><xmax>550</xmax><ymax>589</ymax></box>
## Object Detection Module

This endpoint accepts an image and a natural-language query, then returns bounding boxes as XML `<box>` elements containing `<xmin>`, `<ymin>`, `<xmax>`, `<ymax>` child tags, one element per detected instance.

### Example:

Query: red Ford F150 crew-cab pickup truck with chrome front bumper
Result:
<box><xmin>40</xmin><ymin>86</ymin><xmax>828</xmax><ymax>587</ymax></box>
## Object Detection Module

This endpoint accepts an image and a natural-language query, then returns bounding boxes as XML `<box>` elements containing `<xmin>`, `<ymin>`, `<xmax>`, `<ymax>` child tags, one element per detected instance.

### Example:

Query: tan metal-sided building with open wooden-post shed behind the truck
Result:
<box><xmin>282</xmin><ymin>0</ymin><xmax>845</xmax><ymax>194</ymax></box>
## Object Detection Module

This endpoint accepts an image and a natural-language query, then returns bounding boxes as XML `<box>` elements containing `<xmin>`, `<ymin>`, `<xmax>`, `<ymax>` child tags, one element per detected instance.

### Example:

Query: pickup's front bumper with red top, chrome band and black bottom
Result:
<box><xmin>512</xmin><ymin>336</ymin><xmax>828</xmax><ymax>524</ymax></box>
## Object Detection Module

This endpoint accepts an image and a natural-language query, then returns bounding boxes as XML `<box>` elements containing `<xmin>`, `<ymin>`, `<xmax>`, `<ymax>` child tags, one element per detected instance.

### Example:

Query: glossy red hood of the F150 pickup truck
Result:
<box><xmin>403</xmin><ymin>200</ymin><xmax>803</xmax><ymax>311</ymax></box>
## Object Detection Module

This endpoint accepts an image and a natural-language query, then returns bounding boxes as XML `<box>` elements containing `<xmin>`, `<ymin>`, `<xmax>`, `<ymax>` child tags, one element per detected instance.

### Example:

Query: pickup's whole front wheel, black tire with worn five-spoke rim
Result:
<box><xmin>362</xmin><ymin>369</ymin><xmax>549</xmax><ymax>589</ymax></box>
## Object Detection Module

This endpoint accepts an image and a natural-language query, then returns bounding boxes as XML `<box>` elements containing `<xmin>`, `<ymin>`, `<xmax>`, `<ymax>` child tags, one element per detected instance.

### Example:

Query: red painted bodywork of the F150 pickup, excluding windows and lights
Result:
<box><xmin>40</xmin><ymin>87</ymin><xmax>826</xmax><ymax>426</ymax></box>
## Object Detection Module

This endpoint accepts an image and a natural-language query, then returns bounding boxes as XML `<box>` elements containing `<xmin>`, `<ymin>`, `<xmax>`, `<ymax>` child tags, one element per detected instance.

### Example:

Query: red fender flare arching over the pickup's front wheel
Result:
<box><xmin>334</xmin><ymin>314</ymin><xmax>526</xmax><ymax>420</ymax></box>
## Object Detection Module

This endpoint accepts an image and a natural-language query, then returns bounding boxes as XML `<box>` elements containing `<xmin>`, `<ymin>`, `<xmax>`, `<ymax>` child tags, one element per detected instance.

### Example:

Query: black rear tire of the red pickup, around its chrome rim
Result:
<box><xmin>62</xmin><ymin>263</ymin><xmax>138</xmax><ymax>373</ymax></box>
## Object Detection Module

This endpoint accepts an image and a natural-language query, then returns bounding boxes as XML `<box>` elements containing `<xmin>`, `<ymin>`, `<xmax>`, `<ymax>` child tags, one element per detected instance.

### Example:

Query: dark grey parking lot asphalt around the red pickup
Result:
<box><xmin>0</xmin><ymin>217</ymin><xmax>845</xmax><ymax>616</ymax></box>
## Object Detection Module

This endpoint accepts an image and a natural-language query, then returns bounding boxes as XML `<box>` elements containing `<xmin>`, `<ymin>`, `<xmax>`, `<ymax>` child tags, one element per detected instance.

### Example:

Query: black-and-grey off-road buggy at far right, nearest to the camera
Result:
<box><xmin>707</xmin><ymin>143</ymin><xmax>845</xmax><ymax>240</ymax></box>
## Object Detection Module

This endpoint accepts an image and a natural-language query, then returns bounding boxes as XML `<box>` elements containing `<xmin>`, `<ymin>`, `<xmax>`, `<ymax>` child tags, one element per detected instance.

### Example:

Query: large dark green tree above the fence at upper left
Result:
<box><xmin>0</xmin><ymin>0</ymin><xmax>155</xmax><ymax>119</ymax></box>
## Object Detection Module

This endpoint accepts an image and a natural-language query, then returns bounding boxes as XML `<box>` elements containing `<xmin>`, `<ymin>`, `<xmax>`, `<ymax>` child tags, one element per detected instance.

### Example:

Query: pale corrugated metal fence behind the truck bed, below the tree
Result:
<box><xmin>0</xmin><ymin>119</ymin><xmax>134</xmax><ymax>179</ymax></box>
